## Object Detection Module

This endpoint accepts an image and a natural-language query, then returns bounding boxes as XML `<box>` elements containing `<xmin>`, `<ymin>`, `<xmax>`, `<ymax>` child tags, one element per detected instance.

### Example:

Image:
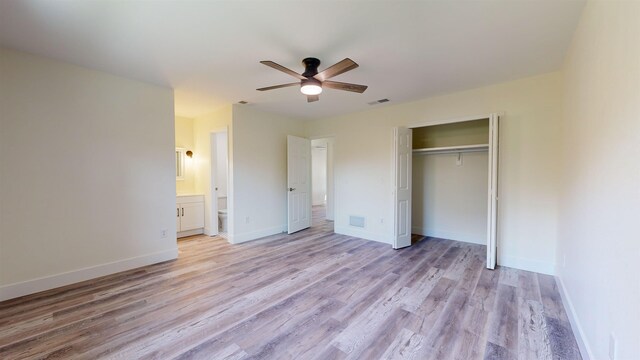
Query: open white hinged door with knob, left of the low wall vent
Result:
<box><xmin>287</xmin><ymin>135</ymin><xmax>311</xmax><ymax>234</ymax></box>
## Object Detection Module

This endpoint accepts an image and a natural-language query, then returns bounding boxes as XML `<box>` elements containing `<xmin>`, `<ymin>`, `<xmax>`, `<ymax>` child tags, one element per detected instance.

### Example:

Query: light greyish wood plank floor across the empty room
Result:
<box><xmin>0</xmin><ymin>208</ymin><xmax>580</xmax><ymax>360</ymax></box>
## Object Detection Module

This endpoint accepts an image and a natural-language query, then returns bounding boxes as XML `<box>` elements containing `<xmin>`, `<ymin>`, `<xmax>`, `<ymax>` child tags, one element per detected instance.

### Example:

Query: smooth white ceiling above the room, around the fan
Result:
<box><xmin>0</xmin><ymin>0</ymin><xmax>584</xmax><ymax>118</ymax></box>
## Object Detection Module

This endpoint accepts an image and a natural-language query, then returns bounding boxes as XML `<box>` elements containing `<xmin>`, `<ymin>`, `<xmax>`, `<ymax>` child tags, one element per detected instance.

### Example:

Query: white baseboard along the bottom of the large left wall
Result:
<box><xmin>0</xmin><ymin>246</ymin><xmax>178</xmax><ymax>301</ymax></box>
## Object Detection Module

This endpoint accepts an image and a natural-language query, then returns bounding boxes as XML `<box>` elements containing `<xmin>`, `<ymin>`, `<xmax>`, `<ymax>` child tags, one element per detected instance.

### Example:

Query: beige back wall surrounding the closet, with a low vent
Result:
<box><xmin>308</xmin><ymin>73</ymin><xmax>562</xmax><ymax>273</ymax></box>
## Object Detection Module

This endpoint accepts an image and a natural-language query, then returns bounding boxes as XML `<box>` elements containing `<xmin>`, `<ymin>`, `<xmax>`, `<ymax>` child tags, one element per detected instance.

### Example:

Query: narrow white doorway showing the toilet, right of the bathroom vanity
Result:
<box><xmin>209</xmin><ymin>129</ymin><xmax>230</xmax><ymax>238</ymax></box>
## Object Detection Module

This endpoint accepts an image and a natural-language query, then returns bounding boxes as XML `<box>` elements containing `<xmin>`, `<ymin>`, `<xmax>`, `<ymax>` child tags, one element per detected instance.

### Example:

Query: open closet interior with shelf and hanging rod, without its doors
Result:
<box><xmin>411</xmin><ymin>119</ymin><xmax>489</xmax><ymax>245</ymax></box>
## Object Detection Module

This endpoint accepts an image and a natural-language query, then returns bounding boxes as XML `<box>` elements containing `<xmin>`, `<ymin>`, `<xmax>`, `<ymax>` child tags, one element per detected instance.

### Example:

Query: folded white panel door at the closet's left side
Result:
<box><xmin>393</xmin><ymin>127</ymin><xmax>412</xmax><ymax>249</ymax></box>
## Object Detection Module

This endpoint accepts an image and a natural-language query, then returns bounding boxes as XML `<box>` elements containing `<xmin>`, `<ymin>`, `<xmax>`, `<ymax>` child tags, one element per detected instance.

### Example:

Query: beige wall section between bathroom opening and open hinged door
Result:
<box><xmin>230</xmin><ymin>105</ymin><xmax>305</xmax><ymax>243</ymax></box>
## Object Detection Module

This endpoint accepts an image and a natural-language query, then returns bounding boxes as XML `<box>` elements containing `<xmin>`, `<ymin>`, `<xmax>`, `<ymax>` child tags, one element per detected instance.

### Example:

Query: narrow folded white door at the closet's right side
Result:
<box><xmin>487</xmin><ymin>114</ymin><xmax>500</xmax><ymax>269</ymax></box>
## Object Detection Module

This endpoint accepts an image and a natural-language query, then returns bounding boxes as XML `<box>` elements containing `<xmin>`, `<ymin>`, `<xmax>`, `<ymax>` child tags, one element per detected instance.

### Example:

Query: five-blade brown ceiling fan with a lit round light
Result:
<box><xmin>257</xmin><ymin>58</ymin><xmax>367</xmax><ymax>102</ymax></box>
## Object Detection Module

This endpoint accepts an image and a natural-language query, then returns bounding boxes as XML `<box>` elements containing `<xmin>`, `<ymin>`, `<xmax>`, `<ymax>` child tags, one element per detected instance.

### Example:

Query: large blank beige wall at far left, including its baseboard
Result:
<box><xmin>0</xmin><ymin>49</ymin><xmax>177</xmax><ymax>300</ymax></box>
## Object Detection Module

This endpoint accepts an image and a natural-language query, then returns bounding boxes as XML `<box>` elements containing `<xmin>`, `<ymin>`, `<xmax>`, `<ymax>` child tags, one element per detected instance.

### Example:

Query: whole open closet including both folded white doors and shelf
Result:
<box><xmin>393</xmin><ymin>114</ymin><xmax>499</xmax><ymax>269</ymax></box>
